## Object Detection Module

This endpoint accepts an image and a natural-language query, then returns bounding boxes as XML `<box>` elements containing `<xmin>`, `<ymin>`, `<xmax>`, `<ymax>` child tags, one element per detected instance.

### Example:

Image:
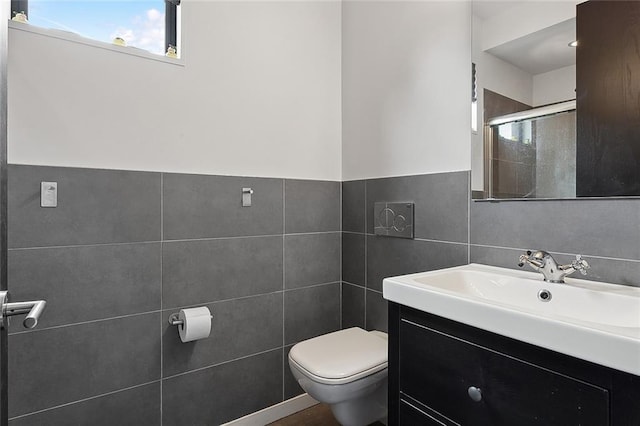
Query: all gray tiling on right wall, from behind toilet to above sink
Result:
<box><xmin>342</xmin><ymin>171</ymin><xmax>640</xmax><ymax>330</ymax></box>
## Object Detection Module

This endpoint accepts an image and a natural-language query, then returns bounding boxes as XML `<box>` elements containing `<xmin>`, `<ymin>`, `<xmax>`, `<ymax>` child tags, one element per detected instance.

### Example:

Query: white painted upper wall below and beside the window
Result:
<box><xmin>8</xmin><ymin>1</ymin><xmax>341</xmax><ymax>180</ymax></box>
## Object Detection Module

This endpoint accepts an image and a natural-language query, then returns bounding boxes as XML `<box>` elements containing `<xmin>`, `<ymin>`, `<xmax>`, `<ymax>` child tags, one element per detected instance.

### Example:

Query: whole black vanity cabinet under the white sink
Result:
<box><xmin>389</xmin><ymin>302</ymin><xmax>640</xmax><ymax>426</ymax></box>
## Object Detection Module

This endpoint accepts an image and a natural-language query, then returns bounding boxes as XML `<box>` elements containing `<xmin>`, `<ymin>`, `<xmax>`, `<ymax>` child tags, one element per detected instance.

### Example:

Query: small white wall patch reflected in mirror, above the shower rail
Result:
<box><xmin>533</xmin><ymin>65</ymin><xmax>576</xmax><ymax>106</ymax></box>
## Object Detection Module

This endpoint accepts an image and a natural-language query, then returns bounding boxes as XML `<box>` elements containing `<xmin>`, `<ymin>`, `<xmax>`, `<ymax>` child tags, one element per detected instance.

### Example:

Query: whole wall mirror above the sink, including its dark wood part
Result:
<box><xmin>471</xmin><ymin>0</ymin><xmax>640</xmax><ymax>199</ymax></box>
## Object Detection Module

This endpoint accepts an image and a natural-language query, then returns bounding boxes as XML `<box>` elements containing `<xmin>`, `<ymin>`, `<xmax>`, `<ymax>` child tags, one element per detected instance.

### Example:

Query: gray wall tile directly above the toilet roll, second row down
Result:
<box><xmin>162</xmin><ymin>236</ymin><xmax>283</xmax><ymax>308</ymax></box>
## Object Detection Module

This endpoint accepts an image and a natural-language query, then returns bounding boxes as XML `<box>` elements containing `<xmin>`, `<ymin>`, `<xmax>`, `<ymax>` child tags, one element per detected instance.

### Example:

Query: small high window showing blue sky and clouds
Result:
<box><xmin>11</xmin><ymin>0</ymin><xmax>180</xmax><ymax>55</ymax></box>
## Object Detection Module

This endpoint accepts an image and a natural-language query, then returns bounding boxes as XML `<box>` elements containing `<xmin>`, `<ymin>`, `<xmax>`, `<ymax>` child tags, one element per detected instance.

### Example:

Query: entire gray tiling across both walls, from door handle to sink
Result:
<box><xmin>8</xmin><ymin>165</ymin><xmax>640</xmax><ymax>425</ymax></box>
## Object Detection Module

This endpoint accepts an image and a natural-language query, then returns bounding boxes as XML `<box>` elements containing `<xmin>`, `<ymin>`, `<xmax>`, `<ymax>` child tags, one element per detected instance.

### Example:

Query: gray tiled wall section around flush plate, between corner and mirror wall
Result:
<box><xmin>342</xmin><ymin>172</ymin><xmax>469</xmax><ymax>331</ymax></box>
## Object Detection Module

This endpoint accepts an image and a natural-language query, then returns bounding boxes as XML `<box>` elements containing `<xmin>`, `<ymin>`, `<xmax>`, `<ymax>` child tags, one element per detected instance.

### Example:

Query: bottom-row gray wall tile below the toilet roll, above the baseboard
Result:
<box><xmin>162</xmin><ymin>349</ymin><xmax>283</xmax><ymax>426</ymax></box>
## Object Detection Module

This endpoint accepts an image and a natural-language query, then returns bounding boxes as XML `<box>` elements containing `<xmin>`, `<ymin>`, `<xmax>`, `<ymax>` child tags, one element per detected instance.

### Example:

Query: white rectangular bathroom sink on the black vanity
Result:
<box><xmin>383</xmin><ymin>264</ymin><xmax>640</xmax><ymax>376</ymax></box>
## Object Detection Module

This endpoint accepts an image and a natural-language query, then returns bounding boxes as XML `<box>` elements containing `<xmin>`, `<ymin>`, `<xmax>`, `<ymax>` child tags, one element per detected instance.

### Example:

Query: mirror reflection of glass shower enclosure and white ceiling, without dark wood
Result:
<box><xmin>472</xmin><ymin>1</ymin><xmax>579</xmax><ymax>198</ymax></box>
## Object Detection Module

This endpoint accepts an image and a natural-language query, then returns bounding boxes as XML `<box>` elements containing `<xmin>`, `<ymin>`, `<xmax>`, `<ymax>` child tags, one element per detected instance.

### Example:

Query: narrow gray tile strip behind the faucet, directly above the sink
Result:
<box><xmin>471</xmin><ymin>245</ymin><xmax>640</xmax><ymax>287</ymax></box>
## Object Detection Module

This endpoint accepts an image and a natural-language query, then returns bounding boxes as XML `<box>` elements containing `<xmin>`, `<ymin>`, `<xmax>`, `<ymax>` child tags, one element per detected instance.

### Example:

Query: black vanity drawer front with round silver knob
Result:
<box><xmin>399</xmin><ymin>321</ymin><xmax>609</xmax><ymax>426</ymax></box>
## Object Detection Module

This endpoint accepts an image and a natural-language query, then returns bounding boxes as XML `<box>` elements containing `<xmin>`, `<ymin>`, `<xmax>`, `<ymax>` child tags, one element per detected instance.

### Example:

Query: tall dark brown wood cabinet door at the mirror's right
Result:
<box><xmin>576</xmin><ymin>0</ymin><xmax>640</xmax><ymax>197</ymax></box>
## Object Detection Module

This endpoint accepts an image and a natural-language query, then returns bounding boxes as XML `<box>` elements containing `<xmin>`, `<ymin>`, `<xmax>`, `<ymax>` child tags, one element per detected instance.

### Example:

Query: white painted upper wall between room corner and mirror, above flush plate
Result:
<box><xmin>342</xmin><ymin>1</ymin><xmax>471</xmax><ymax>180</ymax></box>
